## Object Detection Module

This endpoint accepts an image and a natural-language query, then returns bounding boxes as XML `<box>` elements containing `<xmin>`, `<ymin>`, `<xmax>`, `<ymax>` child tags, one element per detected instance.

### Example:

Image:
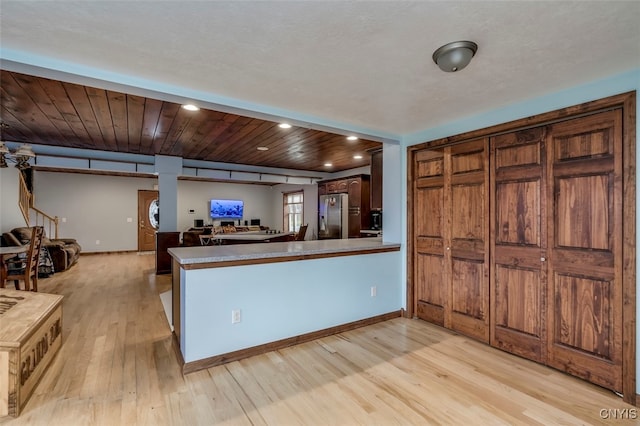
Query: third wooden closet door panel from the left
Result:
<box><xmin>490</xmin><ymin>127</ymin><xmax>547</xmax><ymax>362</ymax></box>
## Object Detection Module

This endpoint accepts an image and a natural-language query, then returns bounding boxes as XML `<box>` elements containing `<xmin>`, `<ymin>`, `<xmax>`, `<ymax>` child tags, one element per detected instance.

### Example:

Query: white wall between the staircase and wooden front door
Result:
<box><xmin>34</xmin><ymin>171</ymin><xmax>157</xmax><ymax>253</ymax></box>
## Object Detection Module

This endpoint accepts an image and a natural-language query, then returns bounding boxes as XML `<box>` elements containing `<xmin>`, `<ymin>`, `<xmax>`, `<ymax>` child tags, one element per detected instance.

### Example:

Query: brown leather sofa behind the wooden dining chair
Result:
<box><xmin>2</xmin><ymin>226</ymin><xmax>82</xmax><ymax>272</ymax></box>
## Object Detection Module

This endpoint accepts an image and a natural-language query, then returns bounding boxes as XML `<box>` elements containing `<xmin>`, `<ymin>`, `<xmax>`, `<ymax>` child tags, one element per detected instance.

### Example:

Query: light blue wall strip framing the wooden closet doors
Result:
<box><xmin>400</xmin><ymin>69</ymin><xmax>640</xmax><ymax>393</ymax></box>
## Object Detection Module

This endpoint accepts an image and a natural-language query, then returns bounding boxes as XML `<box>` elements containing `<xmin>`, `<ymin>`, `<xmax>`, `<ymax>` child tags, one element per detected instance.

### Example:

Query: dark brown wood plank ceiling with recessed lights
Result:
<box><xmin>0</xmin><ymin>70</ymin><xmax>381</xmax><ymax>172</ymax></box>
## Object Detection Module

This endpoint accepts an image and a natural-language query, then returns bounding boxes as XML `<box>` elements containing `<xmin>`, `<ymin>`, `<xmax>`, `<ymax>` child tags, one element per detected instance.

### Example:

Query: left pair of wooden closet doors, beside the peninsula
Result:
<box><xmin>414</xmin><ymin>139</ymin><xmax>489</xmax><ymax>342</ymax></box>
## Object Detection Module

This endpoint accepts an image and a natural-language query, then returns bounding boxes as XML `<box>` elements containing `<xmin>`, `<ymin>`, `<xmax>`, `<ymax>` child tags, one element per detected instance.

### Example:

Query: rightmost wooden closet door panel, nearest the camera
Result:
<box><xmin>547</xmin><ymin>110</ymin><xmax>623</xmax><ymax>392</ymax></box>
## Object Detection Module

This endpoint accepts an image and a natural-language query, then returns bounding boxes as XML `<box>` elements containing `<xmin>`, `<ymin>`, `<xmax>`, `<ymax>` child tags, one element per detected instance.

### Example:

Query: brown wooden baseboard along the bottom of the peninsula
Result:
<box><xmin>180</xmin><ymin>309</ymin><xmax>403</xmax><ymax>374</ymax></box>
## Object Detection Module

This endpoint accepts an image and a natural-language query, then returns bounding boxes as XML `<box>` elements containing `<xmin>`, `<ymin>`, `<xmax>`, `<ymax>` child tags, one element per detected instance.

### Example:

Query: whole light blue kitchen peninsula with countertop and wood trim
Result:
<box><xmin>169</xmin><ymin>238</ymin><xmax>403</xmax><ymax>373</ymax></box>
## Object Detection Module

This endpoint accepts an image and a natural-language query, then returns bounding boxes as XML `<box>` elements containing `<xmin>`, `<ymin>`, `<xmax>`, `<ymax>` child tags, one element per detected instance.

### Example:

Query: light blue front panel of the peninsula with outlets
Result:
<box><xmin>180</xmin><ymin>251</ymin><xmax>404</xmax><ymax>362</ymax></box>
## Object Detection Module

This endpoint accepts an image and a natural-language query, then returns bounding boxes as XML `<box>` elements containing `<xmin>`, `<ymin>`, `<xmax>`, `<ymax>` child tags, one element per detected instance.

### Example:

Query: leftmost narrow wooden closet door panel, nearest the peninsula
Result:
<box><xmin>413</xmin><ymin>148</ymin><xmax>450</xmax><ymax>326</ymax></box>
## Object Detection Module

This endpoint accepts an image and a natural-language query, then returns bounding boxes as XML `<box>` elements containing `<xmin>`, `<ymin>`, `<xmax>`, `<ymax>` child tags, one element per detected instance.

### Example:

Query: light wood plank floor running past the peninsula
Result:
<box><xmin>0</xmin><ymin>253</ymin><xmax>637</xmax><ymax>425</ymax></box>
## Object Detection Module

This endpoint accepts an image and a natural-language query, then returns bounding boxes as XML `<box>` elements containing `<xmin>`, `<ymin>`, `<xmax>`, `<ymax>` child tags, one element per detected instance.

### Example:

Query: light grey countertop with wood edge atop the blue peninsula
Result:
<box><xmin>169</xmin><ymin>238</ymin><xmax>400</xmax><ymax>269</ymax></box>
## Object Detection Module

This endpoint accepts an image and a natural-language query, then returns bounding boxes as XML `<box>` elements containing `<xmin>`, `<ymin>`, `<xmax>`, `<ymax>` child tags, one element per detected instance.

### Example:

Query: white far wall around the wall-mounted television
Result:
<box><xmin>176</xmin><ymin>180</ymin><xmax>282</xmax><ymax>231</ymax></box>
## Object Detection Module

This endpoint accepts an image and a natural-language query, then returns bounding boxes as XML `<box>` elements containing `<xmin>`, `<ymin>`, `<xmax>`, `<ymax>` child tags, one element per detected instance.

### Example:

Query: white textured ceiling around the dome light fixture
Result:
<box><xmin>0</xmin><ymin>0</ymin><xmax>640</xmax><ymax>137</ymax></box>
